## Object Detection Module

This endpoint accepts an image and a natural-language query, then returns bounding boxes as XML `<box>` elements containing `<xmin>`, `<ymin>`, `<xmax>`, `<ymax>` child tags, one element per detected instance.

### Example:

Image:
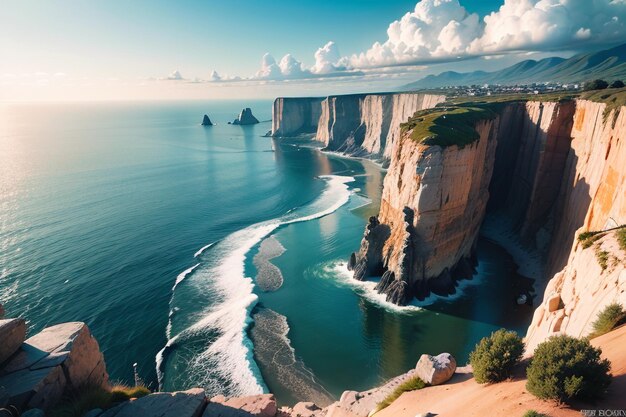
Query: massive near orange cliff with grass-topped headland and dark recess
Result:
<box><xmin>349</xmin><ymin>97</ymin><xmax>626</xmax><ymax>304</ymax></box>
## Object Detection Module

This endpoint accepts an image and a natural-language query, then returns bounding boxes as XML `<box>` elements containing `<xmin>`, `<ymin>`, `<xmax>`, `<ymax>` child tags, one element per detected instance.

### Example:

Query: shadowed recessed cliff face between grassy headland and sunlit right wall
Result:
<box><xmin>490</xmin><ymin>101</ymin><xmax>575</xmax><ymax>245</ymax></box>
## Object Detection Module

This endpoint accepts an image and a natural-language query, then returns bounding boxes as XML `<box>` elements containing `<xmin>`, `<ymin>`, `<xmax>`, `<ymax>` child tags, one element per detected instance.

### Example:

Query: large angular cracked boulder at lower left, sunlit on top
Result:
<box><xmin>0</xmin><ymin>322</ymin><xmax>108</xmax><ymax>410</ymax></box>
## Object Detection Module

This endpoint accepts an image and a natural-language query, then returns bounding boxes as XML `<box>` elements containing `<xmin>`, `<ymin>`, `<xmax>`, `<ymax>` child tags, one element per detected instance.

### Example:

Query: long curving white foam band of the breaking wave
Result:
<box><xmin>156</xmin><ymin>175</ymin><xmax>354</xmax><ymax>396</ymax></box>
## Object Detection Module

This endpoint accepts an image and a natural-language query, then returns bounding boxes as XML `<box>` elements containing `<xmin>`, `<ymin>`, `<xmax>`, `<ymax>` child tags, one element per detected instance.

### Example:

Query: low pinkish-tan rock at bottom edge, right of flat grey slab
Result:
<box><xmin>202</xmin><ymin>394</ymin><xmax>278</xmax><ymax>417</ymax></box>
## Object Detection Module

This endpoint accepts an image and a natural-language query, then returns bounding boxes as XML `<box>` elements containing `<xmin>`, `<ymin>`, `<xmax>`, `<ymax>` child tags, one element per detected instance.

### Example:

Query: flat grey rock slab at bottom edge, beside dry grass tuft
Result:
<box><xmin>100</xmin><ymin>388</ymin><xmax>206</xmax><ymax>417</ymax></box>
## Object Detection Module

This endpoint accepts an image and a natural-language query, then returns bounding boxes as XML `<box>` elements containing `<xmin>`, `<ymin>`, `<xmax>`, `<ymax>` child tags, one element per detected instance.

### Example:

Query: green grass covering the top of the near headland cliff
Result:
<box><xmin>401</xmin><ymin>93</ymin><xmax>576</xmax><ymax>148</ymax></box>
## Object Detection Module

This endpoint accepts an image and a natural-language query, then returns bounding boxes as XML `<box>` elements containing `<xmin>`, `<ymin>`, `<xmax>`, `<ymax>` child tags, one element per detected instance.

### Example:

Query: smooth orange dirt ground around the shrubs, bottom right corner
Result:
<box><xmin>376</xmin><ymin>326</ymin><xmax>626</xmax><ymax>417</ymax></box>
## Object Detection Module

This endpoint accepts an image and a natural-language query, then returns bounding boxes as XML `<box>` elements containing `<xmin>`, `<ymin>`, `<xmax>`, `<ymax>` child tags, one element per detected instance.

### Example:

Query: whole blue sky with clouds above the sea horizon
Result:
<box><xmin>0</xmin><ymin>0</ymin><xmax>626</xmax><ymax>101</ymax></box>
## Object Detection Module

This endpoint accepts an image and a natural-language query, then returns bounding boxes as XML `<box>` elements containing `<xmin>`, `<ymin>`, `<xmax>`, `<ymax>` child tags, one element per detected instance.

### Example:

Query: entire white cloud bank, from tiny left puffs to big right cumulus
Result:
<box><xmin>179</xmin><ymin>0</ymin><xmax>626</xmax><ymax>82</ymax></box>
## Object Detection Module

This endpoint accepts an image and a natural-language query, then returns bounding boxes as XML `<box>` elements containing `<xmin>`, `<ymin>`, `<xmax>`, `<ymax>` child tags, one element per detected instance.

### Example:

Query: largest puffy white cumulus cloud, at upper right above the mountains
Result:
<box><xmin>350</xmin><ymin>0</ymin><xmax>626</xmax><ymax>67</ymax></box>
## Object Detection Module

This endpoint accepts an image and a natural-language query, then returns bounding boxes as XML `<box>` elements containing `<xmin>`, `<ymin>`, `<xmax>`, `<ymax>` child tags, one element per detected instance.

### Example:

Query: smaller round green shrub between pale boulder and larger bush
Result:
<box><xmin>470</xmin><ymin>329</ymin><xmax>524</xmax><ymax>384</ymax></box>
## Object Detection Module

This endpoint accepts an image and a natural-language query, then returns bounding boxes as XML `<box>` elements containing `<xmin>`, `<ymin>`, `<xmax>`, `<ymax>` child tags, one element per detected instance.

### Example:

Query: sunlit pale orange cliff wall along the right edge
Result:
<box><xmin>527</xmin><ymin>100</ymin><xmax>626</xmax><ymax>351</ymax></box>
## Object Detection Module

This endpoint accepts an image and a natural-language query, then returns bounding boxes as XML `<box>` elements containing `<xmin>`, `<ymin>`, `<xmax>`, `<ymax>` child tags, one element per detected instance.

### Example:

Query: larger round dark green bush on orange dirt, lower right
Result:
<box><xmin>526</xmin><ymin>335</ymin><xmax>611</xmax><ymax>402</ymax></box>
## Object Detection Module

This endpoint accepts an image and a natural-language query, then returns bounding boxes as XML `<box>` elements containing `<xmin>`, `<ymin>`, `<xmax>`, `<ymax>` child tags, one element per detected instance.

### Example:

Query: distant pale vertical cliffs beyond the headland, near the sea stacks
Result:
<box><xmin>272</xmin><ymin>93</ymin><xmax>445</xmax><ymax>162</ymax></box>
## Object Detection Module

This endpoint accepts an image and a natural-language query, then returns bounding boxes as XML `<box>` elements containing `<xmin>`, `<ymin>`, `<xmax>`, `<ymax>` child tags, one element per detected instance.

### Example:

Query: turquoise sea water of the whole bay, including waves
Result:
<box><xmin>0</xmin><ymin>101</ymin><xmax>532</xmax><ymax>403</ymax></box>
